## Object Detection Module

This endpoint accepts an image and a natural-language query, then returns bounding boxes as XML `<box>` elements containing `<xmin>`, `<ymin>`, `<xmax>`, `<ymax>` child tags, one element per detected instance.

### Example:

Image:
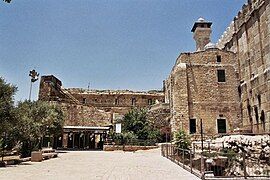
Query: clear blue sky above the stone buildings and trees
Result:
<box><xmin>0</xmin><ymin>0</ymin><xmax>246</xmax><ymax>101</ymax></box>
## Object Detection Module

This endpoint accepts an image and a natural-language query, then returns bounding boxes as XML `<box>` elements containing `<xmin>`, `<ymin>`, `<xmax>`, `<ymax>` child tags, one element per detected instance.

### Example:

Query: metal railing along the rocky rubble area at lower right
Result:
<box><xmin>161</xmin><ymin>144</ymin><xmax>270</xmax><ymax>179</ymax></box>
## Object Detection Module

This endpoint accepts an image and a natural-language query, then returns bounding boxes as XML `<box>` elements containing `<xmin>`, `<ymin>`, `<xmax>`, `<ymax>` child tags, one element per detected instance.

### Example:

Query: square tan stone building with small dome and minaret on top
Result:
<box><xmin>165</xmin><ymin>18</ymin><xmax>241</xmax><ymax>134</ymax></box>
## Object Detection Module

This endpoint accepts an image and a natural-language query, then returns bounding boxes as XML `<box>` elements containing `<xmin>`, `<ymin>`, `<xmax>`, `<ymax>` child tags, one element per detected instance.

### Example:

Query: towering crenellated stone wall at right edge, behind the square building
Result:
<box><xmin>217</xmin><ymin>0</ymin><xmax>270</xmax><ymax>133</ymax></box>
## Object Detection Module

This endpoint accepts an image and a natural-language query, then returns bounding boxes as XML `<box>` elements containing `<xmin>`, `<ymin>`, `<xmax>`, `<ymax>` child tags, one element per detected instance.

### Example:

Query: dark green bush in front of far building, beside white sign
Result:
<box><xmin>121</xmin><ymin>108</ymin><xmax>161</xmax><ymax>142</ymax></box>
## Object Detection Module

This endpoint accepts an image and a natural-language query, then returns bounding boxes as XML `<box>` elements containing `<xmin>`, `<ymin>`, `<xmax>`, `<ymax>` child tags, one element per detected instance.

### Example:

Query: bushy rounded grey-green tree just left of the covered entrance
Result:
<box><xmin>14</xmin><ymin>101</ymin><xmax>64</xmax><ymax>157</ymax></box>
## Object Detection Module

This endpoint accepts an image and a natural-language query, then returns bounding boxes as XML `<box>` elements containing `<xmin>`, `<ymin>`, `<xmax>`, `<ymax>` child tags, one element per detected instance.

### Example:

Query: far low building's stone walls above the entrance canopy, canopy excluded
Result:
<box><xmin>39</xmin><ymin>75</ymin><xmax>164</xmax><ymax>126</ymax></box>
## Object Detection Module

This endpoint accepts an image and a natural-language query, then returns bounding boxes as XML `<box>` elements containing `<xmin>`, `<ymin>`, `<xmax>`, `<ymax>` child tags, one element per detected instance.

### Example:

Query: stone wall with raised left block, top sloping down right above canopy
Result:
<box><xmin>39</xmin><ymin>75</ymin><xmax>112</xmax><ymax>126</ymax></box>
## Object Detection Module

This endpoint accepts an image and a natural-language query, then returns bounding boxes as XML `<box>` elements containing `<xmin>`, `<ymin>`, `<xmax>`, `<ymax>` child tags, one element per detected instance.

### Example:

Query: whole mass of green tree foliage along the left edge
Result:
<box><xmin>0</xmin><ymin>77</ymin><xmax>64</xmax><ymax>156</ymax></box>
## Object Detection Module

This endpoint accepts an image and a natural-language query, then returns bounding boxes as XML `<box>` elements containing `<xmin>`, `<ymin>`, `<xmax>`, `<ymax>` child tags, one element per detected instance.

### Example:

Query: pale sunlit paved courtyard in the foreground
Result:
<box><xmin>0</xmin><ymin>149</ymin><xmax>199</xmax><ymax>180</ymax></box>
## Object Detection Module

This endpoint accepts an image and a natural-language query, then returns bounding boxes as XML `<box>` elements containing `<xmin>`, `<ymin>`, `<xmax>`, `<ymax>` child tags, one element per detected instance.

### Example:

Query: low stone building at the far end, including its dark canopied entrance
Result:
<box><xmin>39</xmin><ymin>75</ymin><xmax>164</xmax><ymax>149</ymax></box>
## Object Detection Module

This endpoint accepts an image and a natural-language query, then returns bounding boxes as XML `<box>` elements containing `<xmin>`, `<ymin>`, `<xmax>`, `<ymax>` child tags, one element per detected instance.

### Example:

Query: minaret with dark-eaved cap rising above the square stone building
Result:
<box><xmin>191</xmin><ymin>18</ymin><xmax>212</xmax><ymax>51</ymax></box>
